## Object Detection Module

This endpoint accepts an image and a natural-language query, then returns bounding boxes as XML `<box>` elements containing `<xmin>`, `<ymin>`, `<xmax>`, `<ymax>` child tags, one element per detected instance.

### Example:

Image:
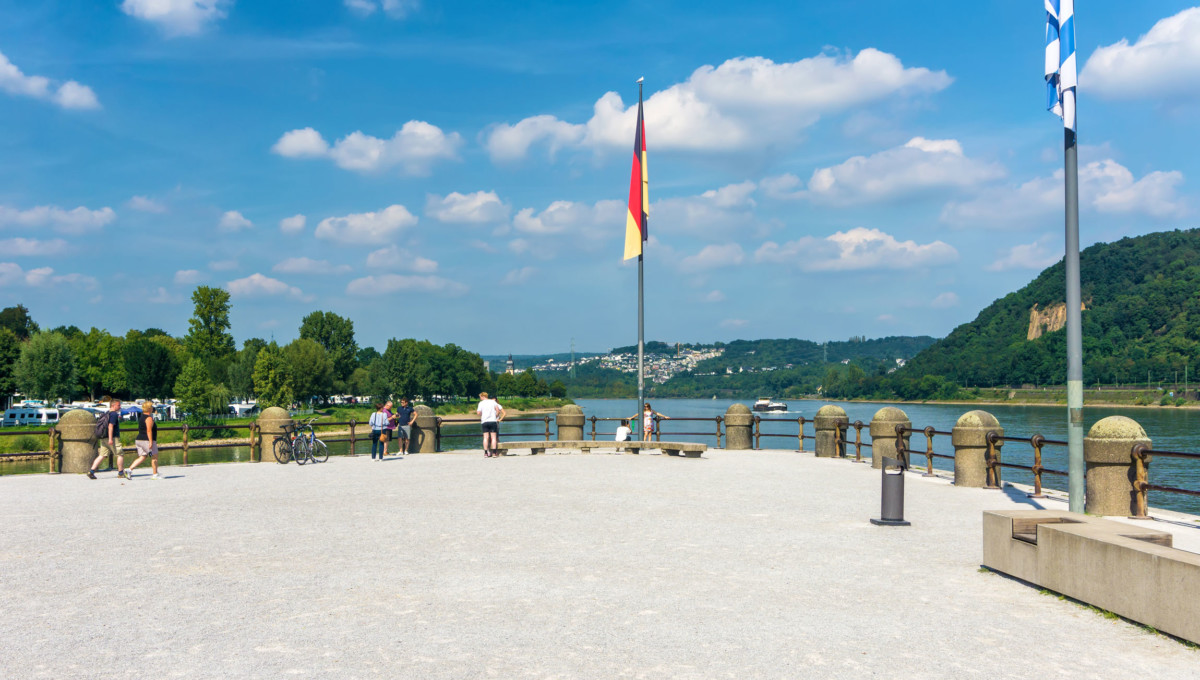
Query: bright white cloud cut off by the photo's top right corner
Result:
<box><xmin>1079</xmin><ymin>7</ymin><xmax>1200</xmax><ymax>100</ymax></box>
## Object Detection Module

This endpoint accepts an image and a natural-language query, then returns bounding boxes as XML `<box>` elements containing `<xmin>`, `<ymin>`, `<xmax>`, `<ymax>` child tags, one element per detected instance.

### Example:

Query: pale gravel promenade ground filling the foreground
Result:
<box><xmin>0</xmin><ymin>451</ymin><xmax>1200</xmax><ymax>680</ymax></box>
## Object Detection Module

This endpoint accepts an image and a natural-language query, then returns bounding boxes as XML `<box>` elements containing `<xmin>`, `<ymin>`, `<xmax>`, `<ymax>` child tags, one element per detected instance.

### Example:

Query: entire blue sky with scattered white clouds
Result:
<box><xmin>0</xmin><ymin>0</ymin><xmax>1200</xmax><ymax>354</ymax></box>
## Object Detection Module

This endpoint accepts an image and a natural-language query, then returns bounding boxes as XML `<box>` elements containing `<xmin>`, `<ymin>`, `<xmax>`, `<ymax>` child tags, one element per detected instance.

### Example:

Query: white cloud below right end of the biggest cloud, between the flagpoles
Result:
<box><xmin>782</xmin><ymin>137</ymin><xmax>1004</xmax><ymax>205</ymax></box>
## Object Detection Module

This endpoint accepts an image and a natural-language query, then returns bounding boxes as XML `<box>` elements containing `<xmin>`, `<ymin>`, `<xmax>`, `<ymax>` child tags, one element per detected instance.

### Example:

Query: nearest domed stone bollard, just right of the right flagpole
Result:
<box><xmin>1084</xmin><ymin>416</ymin><xmax>1151</xmax><ymax>517</ymax></box>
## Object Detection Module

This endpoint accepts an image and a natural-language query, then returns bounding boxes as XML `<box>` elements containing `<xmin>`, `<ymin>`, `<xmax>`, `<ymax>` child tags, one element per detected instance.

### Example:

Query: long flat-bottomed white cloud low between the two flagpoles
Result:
<box><xmin>755</xmin><ymin>227</ymin><xmax>959</xmax><ymax>271</ymax></box>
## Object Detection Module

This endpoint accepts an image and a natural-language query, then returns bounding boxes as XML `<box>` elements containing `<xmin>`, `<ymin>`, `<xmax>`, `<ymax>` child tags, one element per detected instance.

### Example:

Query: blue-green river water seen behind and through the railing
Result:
<box><xmin>9</xmin><ymin>399</ymin><xmax>1200</xmax><ymax>514</ymax></box>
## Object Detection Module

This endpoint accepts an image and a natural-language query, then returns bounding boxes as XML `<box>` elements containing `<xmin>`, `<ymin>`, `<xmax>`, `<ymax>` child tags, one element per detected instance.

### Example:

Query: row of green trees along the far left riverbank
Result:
<box><xmin>0</xmin><ymin>285</ymin><xmax>566</xmax><ymax>415</ymax></box>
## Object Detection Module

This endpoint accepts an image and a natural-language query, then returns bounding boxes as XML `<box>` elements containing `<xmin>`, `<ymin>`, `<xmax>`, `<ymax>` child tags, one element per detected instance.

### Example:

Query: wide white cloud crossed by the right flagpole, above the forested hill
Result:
<box><xmin>942</xmin><ymin>158</ymin><xmax>1190</xmax><ymax>228</ymax></box>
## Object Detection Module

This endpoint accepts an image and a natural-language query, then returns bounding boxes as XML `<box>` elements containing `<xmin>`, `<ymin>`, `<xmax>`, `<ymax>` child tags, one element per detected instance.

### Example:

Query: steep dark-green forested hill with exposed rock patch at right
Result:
<box><xmin>895</xmin><ymin>229</ymin><xmax>1200</xmax><ymax>385</ymax></box>
